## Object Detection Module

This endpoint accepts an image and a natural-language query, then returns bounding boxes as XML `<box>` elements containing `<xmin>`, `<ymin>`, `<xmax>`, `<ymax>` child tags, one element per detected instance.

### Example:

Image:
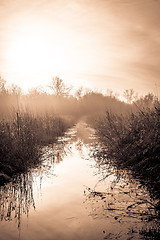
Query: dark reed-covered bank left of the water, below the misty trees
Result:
<box><xmin>0</xmin><ymin>113</ymin><xmax>74</xmax><ymax>184</ymax></box>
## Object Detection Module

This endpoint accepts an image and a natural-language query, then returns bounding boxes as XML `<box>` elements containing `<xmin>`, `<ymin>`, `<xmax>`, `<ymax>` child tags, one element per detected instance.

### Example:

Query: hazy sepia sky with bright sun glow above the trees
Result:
<box><xmin>0</xmin><ymin>0</ymin><xmax>160</xmax><ymax>93</ymax></box>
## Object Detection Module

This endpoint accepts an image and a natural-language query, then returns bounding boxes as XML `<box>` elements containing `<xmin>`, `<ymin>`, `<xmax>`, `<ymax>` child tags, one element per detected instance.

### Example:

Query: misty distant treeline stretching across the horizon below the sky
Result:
<box><xmin>0</xmin><ymin>77</ymin><xmax>157</xmax><ymax>119</ymax></box>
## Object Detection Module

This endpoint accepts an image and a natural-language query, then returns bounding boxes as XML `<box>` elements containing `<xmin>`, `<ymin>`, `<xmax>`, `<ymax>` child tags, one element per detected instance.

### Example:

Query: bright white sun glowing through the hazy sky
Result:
<box><xmin>10</xmin><ymin>33</ymin><xmax>65</xmax><ymax>73</ymax></box>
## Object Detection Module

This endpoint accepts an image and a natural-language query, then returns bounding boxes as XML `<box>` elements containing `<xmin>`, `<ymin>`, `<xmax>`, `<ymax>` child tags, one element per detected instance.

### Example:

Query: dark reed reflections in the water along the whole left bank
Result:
<box><xmin>0</xmin><ymin>141</ymin><xmax>68</xmax><ymax>228</ymax></box>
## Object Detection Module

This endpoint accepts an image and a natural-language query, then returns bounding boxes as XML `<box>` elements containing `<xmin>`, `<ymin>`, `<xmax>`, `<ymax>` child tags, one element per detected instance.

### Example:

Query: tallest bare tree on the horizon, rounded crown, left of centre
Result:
<box><xmin>50</xmin><ymin>76</ymin><xmax>71</xmax><ymax>96</ymax></box>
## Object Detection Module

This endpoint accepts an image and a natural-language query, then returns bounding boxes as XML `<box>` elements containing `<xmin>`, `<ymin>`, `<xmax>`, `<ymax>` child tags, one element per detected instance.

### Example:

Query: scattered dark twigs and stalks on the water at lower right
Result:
<box><xmin>85</xmin><ymin>177</ymin><xmax>158</xmax><ymax>222</ymax></box>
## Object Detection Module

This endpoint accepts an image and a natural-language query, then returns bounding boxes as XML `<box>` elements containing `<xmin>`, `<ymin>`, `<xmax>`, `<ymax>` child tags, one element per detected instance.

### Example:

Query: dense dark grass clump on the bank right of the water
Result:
<box><xmin>94</xmin><ymin>103</ymin><xmax>160</xmax><ymax>198</ymax></box>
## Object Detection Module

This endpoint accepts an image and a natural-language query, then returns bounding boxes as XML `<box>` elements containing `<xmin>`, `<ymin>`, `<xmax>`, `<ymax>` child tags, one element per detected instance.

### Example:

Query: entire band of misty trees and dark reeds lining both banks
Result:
<box><xmin>0</xmin><ymin>77</ymin><xmax>160</xmax><ymax>206</ymax></box>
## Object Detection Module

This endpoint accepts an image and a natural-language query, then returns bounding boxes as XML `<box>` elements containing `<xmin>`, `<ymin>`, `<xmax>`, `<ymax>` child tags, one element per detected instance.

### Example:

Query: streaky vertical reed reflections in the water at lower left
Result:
<box><xmin>0</xmin><ymin>173</ymin><xmax>35</xmax><ymax>228</ymax></box>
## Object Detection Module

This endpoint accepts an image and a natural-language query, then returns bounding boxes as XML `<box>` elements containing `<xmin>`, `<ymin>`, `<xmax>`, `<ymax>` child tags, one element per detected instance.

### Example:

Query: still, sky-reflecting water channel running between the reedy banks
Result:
<box><xmin>0</xmin><ymin>122</ymin><xmax>159</xmax><ymax>240</ymax></box>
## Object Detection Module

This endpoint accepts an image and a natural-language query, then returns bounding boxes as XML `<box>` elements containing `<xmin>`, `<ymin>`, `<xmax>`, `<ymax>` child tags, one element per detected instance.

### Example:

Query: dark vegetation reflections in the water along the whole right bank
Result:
<box><xmin>89</xmin><ymin>143</ymin><xmax>160</xmax><ymax>239</ymax></box>
